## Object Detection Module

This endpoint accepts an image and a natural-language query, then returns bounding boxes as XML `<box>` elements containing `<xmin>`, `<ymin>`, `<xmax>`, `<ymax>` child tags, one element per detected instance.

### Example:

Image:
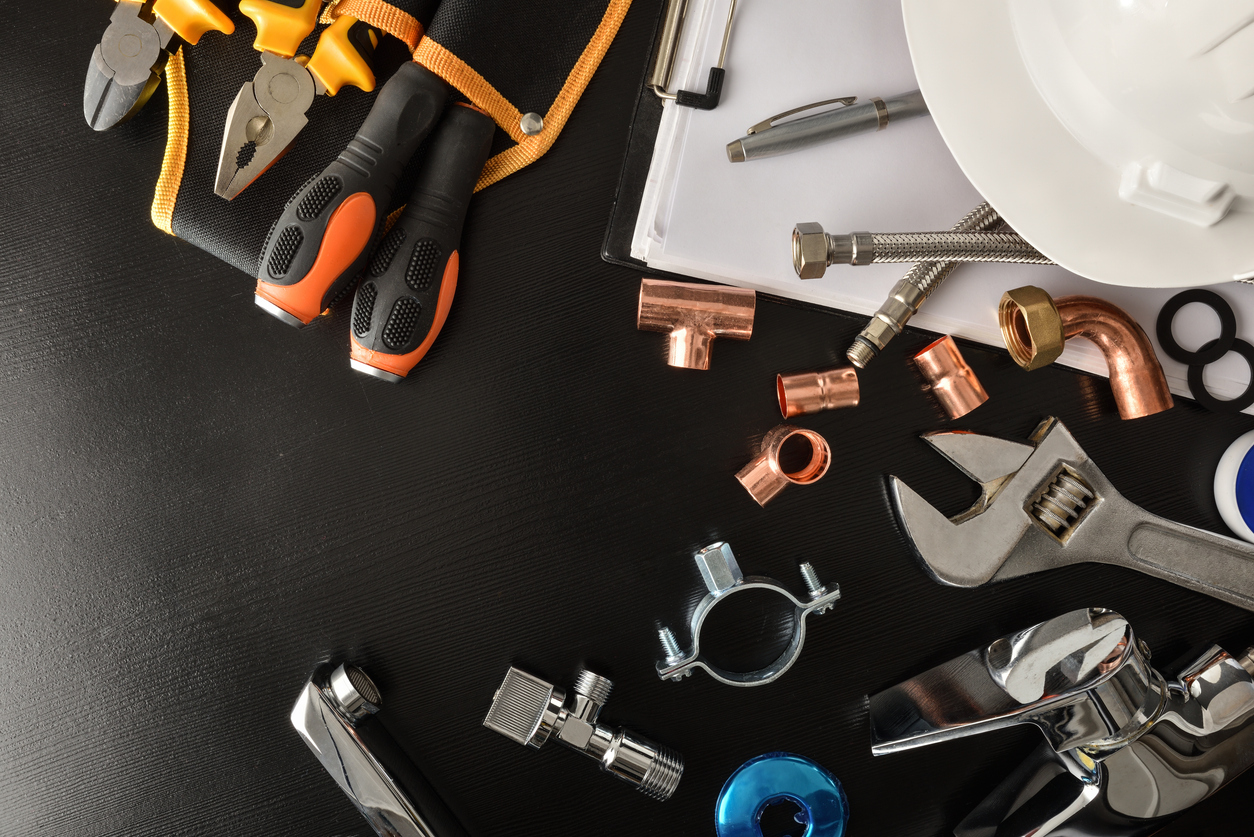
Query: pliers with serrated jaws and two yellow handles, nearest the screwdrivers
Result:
<box><xmin>213</xmin><ymin>0</ymin><xmax>382</xmax><ymax>201</ymax></box>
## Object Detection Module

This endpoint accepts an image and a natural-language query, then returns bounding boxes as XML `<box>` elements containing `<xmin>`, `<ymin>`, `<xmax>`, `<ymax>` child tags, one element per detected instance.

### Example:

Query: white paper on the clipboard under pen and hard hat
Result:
<box><xmin>632</xmin><ymin>0</ymin><xmax>1254</xmax><ymax>412</ymax></box>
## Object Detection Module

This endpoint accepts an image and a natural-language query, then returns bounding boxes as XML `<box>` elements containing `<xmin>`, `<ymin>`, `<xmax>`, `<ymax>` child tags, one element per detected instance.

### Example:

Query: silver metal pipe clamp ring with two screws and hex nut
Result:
<box><xmin>657</xmin><ymin>541</ymin><xmax>840</xmax><ymax>686</ymax></box>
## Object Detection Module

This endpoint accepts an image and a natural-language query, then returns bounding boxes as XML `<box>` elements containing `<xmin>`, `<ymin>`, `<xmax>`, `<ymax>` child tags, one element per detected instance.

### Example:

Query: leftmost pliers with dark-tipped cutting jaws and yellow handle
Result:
<box><xmin>83</xmin><ymin>0</ymin><xmax>234</xmax><ymax>131</ymax></box>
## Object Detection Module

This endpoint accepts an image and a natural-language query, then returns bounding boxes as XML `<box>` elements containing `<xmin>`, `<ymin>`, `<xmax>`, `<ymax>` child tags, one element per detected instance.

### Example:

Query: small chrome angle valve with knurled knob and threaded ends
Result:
<box><xmin>483</xmin><ymin>666</ymin><xmax>683</xmax><ymax>802</ymax></box>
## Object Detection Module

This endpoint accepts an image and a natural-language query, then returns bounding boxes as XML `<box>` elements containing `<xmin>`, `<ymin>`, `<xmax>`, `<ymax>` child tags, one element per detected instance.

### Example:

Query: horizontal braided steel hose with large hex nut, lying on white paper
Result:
<box><xmin>793</xmin><ymin>223</ymin><xmax>1053</xmax><ymax>279</ymax></box>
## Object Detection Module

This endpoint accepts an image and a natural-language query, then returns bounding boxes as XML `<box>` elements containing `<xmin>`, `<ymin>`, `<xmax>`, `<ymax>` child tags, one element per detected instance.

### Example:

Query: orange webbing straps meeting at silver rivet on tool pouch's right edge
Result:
<box><xmin>414</xmin><ymin>0</ymin><xmax>631</xmax><ymax>192</ymax></box>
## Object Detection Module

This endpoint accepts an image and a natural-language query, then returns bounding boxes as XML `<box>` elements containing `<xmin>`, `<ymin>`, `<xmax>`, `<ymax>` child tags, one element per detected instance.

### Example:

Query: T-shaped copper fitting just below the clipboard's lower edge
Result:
<box><xmin>636</xmin><ymin>279</ymin><xmax>757</xmax><ymax>369</ymax></box>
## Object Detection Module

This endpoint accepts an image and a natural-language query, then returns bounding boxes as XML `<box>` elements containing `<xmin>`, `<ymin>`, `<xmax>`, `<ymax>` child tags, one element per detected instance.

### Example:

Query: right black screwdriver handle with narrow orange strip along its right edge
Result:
<box><xmin>350</xmin><ymin>103</ymin><xmax>495</xmax><ymax>381</ymax></box>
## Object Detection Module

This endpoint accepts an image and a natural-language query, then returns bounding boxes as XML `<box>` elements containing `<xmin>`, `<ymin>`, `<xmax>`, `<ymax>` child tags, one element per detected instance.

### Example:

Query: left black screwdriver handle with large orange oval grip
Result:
<box><xmin>256</xmin><ymin>61</ymin><xmax>449</xmax><ymax>328</ymax></box>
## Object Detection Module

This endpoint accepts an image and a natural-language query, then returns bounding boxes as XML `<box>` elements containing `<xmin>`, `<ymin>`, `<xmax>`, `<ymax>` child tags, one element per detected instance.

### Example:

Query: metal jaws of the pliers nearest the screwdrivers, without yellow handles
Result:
<box><xmin>213</xmin><ymin>53</ymin><xmax>319</xmax><ymax>201</ymax></box>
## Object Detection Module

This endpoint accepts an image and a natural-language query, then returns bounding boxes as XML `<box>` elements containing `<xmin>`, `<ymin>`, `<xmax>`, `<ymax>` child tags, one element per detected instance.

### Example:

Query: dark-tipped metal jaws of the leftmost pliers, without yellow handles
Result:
<box><xmin>83</xmin><ymin>0</ymin><xmax>174</xmax><ymax>131</ymax></box>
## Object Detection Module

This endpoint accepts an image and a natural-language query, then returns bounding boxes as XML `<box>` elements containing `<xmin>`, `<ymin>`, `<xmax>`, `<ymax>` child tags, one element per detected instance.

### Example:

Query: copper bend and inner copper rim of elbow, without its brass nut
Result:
<box><xmin>999</xmin><ymin>289</ymin><xmax>1175</xmax><ymax>419</ymax></box>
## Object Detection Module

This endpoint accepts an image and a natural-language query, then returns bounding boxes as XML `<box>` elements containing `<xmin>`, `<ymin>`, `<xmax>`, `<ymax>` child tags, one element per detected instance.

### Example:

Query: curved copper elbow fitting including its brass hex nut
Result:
<box><xmin>997</xmin><ymin>287</ymin><xmax>1175</xmax><ymax>419</ymax></box>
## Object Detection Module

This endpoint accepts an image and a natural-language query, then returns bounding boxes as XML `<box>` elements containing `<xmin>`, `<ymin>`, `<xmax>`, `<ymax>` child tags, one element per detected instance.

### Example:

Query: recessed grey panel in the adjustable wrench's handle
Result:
<box><xmin>1127</xmin><ymin>518</ymin><xmax>1254</xmax><ymax>610</ymax></box>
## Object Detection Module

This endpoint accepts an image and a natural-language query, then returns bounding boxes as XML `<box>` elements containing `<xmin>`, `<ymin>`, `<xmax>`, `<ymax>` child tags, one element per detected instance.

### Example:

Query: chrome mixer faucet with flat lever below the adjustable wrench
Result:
<box><xmin>870</xmin><ymin>609</ymin><xmax>1254</xmax><ymax>837</ymax></box>
